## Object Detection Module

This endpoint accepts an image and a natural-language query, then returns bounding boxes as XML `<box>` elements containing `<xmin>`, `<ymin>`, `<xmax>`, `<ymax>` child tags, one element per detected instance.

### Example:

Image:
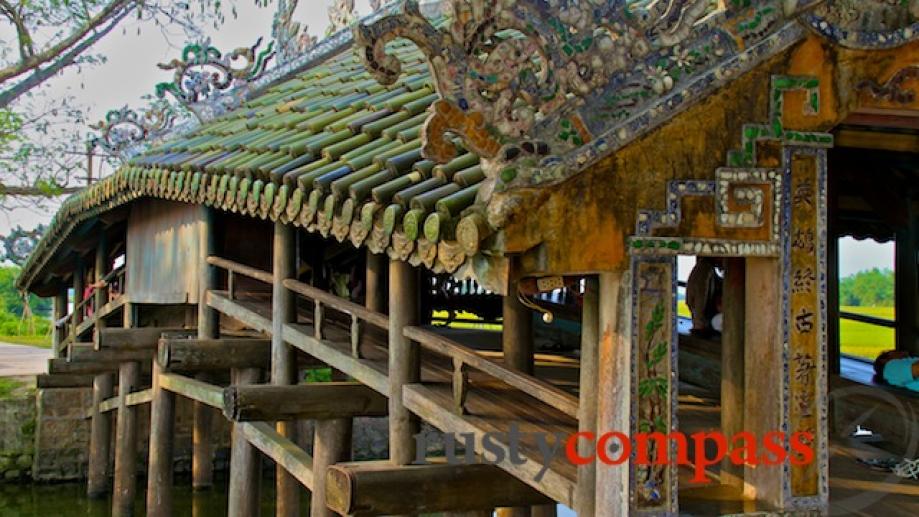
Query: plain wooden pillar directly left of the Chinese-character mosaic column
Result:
<box><xmin>744</xmin><ymin>258</ymin><xmax>783</xmax><ymax>507</ymax></box>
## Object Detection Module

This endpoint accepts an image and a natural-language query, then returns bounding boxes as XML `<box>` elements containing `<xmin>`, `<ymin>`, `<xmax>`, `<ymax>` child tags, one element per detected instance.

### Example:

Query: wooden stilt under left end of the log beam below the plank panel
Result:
<box><xmin>147</xmin><ymin>359</ymin><xmax>175</xmax><ymax>517</ymax></box>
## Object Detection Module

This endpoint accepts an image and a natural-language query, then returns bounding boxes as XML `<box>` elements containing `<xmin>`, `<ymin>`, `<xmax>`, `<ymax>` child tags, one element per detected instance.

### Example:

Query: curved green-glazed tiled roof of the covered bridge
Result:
<box><xmin>19</xmin><ymin>41</ymin><xmax>491</xmax><ymax>287</ymax></box>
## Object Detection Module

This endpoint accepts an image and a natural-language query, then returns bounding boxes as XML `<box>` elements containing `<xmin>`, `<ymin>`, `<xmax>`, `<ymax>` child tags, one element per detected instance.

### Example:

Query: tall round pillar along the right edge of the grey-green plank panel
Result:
<box><xmin>191</xmin><ymin>209</ymin><xmax>220</xmax><ymax>490</ymax></box>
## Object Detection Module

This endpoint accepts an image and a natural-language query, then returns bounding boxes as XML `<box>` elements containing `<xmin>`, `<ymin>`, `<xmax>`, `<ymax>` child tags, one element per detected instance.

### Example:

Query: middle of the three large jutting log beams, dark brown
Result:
<box><xmin>223</xmin><ymin>382</ymin><xmax>388</xmax><ymax>422</ymax></box>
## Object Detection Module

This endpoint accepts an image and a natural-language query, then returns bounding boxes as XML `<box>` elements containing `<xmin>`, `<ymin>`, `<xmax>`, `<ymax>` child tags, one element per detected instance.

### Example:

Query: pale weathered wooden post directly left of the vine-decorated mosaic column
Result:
<box><xmin>594</xmin><ymin>271</ymin><xmax>632</xmax><ymax>517</ymax></box>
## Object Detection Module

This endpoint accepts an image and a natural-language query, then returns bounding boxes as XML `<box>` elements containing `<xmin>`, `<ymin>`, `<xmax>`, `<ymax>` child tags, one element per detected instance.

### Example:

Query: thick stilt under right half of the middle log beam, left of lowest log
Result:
<box><xmin>310</xmin><ymin>417</ymin><xmax>352</xmax><ymax>517</ymax></box>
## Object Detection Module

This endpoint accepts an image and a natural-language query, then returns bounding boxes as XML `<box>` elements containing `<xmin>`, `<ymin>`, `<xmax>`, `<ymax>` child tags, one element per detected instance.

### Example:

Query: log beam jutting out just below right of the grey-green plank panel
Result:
<box><xmin>156</xmin><ymin>339</ymin><xmax>271</xmax><ymax>372</ymax></box>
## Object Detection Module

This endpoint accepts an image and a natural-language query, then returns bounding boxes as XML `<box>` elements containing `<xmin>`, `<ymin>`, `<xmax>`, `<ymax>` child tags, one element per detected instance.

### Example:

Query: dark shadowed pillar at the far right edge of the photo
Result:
<box><xmin>894</xmin><ymin>199</ymin><xmax>919</xmax><ymax>355</ymax></box>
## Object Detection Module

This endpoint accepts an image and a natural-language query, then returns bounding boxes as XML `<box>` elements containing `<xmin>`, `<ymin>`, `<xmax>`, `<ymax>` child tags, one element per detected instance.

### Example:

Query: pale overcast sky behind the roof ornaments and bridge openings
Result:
<box><xmin>0</xmin><ymin>0</ymin><xmax>893</xmax><ymax>276</ymax></box>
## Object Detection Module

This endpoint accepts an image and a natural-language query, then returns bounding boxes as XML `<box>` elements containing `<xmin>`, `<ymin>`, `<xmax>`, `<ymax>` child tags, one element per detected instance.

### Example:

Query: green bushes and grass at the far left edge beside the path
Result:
<box><xmin>0</xmin><ymin>266</ymin><xmax>51</xmax><ymax>347</ymax></box>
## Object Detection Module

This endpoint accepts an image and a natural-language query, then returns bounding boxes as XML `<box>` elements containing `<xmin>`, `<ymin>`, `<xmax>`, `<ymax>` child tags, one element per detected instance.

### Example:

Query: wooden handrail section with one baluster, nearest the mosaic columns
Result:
<box><xmin>403</xmin><ymin>327</ymin><xmax>578</xmax><ymax>418</ymax></box>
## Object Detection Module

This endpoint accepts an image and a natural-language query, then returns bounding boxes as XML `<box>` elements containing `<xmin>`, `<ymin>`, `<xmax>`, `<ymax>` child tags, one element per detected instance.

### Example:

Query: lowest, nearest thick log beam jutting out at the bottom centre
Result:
<box><xmin>326</xmin><ymin>461</ymin><xmax>552</xmax><ymax>516</ymax></box>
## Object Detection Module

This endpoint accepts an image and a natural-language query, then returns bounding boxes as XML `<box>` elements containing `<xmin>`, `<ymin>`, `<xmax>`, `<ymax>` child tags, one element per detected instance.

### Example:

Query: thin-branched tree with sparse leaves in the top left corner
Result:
<box><xmin>0</xmin><ymin>0</ymin><xmax>270</xmax><ymax>198</ymax></box>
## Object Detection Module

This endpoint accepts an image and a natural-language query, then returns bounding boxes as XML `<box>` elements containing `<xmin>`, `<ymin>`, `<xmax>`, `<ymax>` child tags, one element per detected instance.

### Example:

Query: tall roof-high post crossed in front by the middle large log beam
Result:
<box><xmin>271</xmin><ymin>223</ymin><xmax>302</xmax><ymax>517</ymax></box>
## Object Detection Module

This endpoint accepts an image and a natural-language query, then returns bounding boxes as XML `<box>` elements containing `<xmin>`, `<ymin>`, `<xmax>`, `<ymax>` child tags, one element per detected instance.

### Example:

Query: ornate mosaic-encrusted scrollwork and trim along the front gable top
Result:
<box><xmin>355</xmin><ymin>0</ymin><xmax>916</xmax><ymax>190</ymax></box>
